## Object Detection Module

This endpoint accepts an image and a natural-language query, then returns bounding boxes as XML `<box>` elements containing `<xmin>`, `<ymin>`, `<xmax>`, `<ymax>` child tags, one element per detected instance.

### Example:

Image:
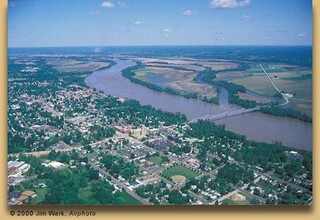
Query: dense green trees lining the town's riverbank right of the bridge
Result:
<box><xmin>185</xmin><ymin>121</ymin><xmax>312</xmax><ymax>176</ymax></box>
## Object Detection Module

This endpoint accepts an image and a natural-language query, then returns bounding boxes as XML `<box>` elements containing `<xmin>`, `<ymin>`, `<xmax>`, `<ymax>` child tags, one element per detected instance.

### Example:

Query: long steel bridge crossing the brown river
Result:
<box><xmin>190</xmin><ymin>106</ymin><xmax>260</xmax><ymax>123</ymax></box>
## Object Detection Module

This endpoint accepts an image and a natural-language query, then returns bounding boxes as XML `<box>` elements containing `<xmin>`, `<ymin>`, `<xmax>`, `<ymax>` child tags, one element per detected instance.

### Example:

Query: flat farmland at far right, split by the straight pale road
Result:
<box><xmin>221</xmin><ymin>65</ymin><xmax>312</xmax><ymax>115</ymax></box>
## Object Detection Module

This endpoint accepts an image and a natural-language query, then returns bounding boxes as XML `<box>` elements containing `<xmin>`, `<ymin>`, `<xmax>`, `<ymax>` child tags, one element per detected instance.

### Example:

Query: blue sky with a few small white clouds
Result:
<box><xmin>8</xmin><ymin>0</ymin><xmax>312</xmax><ymax>47</ymax></box>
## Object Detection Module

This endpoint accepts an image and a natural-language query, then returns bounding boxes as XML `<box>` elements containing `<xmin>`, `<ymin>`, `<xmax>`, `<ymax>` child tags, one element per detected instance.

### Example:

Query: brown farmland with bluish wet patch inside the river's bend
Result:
<box><xmin>128</xmin><ymin>57</ymin><xmax>245</xmax><ymax>99</ymax></box>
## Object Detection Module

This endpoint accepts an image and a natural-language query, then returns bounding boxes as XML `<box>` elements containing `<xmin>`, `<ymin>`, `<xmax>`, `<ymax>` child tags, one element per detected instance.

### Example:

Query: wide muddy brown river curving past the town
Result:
<box><xmin>85</xmin><ymin>60</ymin><xmax>312</xmax><ymax>150</ymax></box>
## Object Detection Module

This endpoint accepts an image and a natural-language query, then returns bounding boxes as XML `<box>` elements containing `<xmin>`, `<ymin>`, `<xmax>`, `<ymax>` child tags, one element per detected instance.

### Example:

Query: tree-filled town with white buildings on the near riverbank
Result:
<box><xmin>8</xmin><ymin>56</ymin><xmax>312</xmax><ymax>205</ymax></box>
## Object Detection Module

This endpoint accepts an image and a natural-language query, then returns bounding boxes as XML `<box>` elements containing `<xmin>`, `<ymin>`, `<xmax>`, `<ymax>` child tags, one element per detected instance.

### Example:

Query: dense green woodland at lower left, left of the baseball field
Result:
<box><xmin>15</xmin><ymin>151</ymin><xmax>139</xmax><ymax>204</ymax></box>
